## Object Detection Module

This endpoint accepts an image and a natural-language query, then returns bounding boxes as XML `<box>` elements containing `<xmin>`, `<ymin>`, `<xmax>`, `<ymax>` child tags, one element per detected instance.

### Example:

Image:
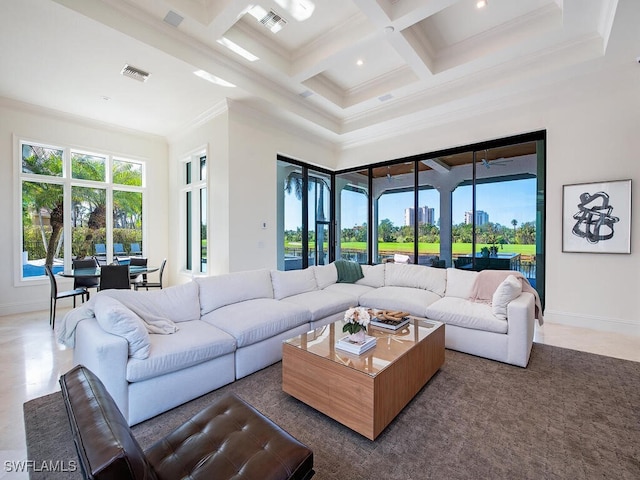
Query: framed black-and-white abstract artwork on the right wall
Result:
<box><xmin>562</xmin><ymin>180</ymin><xmax>631</xmax><ymax>253</ymax></box>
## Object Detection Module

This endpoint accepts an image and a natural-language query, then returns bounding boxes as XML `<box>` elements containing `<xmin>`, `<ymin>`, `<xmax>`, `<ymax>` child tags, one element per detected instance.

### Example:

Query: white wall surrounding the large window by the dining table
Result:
<box><xmin>0</xmin><ymin>99</ymin><xmax>168</xmax><ymax>315</ymax></box>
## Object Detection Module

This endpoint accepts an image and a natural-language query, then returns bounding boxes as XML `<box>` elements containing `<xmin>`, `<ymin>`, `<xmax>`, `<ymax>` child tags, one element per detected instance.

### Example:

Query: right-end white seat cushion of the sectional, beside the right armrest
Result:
<box><xmin>427</xmin><ymin>297</ymin><xmax>508</xmax><ymax>333</ymax></box>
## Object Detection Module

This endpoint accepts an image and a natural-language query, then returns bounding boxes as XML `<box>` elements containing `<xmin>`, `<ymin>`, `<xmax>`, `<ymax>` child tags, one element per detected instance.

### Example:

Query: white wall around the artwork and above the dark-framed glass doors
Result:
<box><xmin>340</xmin><ymin>60</ymin><xmax>640</xmax><ymax>335</ymax></box>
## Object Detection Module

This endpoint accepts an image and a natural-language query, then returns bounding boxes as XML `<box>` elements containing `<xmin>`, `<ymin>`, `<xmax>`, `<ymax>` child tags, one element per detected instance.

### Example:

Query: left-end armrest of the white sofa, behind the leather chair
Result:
<box><xmin>73</xmin><ymin>318</ymin><xmax>129</xmax><ymax>418</ymax></box>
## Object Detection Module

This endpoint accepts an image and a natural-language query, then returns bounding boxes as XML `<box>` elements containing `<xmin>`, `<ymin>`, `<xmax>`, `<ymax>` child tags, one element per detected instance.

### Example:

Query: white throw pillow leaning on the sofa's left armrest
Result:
<box><xmin>93</xmin><ymin>295</ymin><xmax>151</xmax><ymax>360</ymax></box>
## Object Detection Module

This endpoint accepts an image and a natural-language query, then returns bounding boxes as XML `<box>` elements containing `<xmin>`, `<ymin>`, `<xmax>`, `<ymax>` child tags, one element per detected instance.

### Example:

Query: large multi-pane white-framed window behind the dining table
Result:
<box><xmin>20</xmin><ymin>141</ymin><xmax>144</xmax><ymax>279</ymax></box>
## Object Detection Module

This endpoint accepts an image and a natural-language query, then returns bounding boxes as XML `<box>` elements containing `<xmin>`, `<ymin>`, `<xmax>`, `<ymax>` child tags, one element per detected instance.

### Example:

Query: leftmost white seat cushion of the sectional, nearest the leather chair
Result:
<box><xmin>127</xmin><ymin>320</ymin><xmax>236</xmax><ymax>382</ymax></box>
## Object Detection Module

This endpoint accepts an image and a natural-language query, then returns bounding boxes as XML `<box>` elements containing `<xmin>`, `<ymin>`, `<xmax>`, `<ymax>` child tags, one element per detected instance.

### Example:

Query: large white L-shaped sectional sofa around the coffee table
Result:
<box><xmin>56</xmin><ymin>263</ymin><xmax>535</xmax><ymax>425</ymax></box>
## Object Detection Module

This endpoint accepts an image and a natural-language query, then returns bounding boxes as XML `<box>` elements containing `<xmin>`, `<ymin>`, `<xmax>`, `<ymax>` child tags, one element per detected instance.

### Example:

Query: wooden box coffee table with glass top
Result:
<box><xmin>282</xmin><ymin>318</ymin><xmax>445</xmax><ymax>440</ymax></box>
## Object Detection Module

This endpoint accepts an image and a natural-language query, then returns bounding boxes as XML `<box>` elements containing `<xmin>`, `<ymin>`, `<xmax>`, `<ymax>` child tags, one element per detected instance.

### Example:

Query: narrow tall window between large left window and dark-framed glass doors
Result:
<box><xmin>183</xmin><ymin>152</ymin><xmax>208</xmax><ymax>273</ymax></box>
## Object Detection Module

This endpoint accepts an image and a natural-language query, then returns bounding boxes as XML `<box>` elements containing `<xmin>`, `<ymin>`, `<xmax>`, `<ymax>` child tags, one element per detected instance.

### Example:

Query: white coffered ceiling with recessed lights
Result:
<box><xmin>0</xmin><ymin>0</ymin><xmax>618</xmax><ymax>142</ymax></box>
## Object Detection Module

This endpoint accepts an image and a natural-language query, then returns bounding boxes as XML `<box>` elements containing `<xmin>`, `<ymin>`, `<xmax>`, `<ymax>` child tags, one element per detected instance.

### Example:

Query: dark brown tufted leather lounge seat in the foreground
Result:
<box><xmin>60</xmin><ymin>365</ymin><xmax>314</xmax><ymax>480</ymax></box>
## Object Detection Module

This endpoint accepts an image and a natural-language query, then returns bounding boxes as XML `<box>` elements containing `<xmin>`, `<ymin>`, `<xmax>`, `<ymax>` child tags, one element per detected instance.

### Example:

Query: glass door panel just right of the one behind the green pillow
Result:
<box><xmin>372</xmin><ymin>162</ymin><xmax>416</xmax><ymax>263</ymax></box>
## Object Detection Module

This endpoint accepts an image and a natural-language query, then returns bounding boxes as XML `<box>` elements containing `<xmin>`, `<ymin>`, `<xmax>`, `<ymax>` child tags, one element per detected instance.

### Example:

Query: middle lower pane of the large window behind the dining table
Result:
<box><xmin>71</xmin><ymin>187</ymin><xmax>107</xmax><ymax>258</ymax></box>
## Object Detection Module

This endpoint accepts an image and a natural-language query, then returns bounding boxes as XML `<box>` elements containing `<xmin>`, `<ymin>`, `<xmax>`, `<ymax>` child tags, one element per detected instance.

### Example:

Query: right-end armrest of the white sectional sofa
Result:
<box><xmin>507</xmin><ymin>292</ymin><xmax>535</xmax><ymax>367</ymax></box>
